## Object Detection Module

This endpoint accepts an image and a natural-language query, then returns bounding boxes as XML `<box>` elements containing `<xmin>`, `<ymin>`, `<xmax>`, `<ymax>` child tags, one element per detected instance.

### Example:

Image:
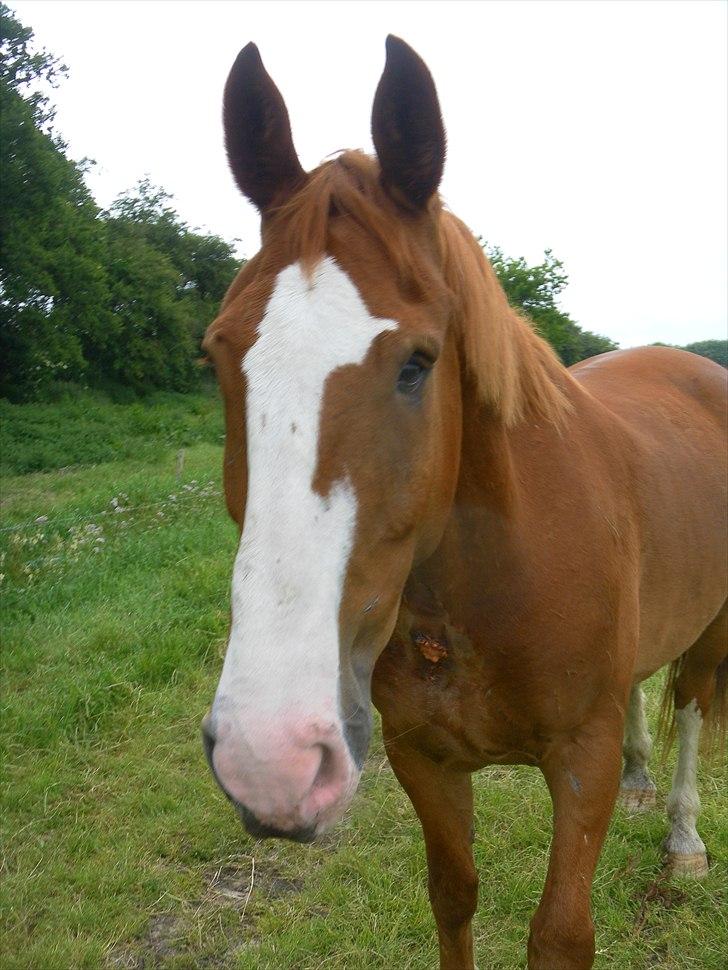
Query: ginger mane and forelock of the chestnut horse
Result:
<box><xmin>264</xmin><ymin>151</ymin><xmax>569</xmax><ymax>425</ymax></box>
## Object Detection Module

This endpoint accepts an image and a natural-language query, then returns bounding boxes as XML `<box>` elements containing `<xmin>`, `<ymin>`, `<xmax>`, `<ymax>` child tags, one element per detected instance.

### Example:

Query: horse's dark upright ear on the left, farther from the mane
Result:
<box><xmin>223</xmin><ymin>44</ymin><xmax>305</xmax><ymax>213</ymax></box>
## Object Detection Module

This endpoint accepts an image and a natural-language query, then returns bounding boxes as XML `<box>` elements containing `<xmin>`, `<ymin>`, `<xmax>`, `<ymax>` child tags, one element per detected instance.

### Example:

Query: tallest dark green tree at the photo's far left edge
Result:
<box><xmin>0</xmin><ymin>4</ymin><xmax>108</xmax><ymax>400</ymax></box>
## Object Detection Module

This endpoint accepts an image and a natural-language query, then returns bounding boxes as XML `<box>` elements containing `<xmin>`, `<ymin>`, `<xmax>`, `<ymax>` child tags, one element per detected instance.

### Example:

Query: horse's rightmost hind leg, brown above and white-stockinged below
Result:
<box><xmin>665</xmin><ymin>605</ymin><xmax>728</xmax><ymax>878</ymax></box>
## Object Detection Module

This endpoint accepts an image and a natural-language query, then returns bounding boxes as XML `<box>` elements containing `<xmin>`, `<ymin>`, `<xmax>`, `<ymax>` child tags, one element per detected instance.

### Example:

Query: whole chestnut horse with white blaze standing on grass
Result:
<box><xmin>203</xmin><ymin>36</ymin><xmax>728</xmax><ymax>970</ymax></box>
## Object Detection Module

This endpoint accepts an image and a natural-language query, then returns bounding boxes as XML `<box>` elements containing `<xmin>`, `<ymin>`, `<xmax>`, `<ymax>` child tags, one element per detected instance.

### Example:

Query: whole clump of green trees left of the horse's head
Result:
<box><xmin>0</xmin><ymin>2</ymin><xmax>238</xmax><ymax>400</ymax></box>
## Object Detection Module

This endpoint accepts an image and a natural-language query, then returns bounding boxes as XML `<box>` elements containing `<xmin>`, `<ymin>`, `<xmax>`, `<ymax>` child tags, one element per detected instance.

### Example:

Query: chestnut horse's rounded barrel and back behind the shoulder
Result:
<box><xmin>570</xmin><ymin>347</ymin><xmax>728</xmax><ymax>676</ymax></box>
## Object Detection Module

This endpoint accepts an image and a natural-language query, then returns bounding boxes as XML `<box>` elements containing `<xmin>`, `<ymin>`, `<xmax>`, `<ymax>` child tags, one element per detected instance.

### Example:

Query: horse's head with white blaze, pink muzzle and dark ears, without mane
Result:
<box><xmin>203</xmin><ymin>41</ymin><xmax>460</xmax><ymax>840</ymax></box>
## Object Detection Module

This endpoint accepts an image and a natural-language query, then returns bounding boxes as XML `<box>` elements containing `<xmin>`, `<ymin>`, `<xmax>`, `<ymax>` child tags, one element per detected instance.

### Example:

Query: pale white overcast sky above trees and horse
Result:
<box><xmin>9</xmin><ymin>0</ymin><xmax>728</xmax><ymax>346</ymax></box>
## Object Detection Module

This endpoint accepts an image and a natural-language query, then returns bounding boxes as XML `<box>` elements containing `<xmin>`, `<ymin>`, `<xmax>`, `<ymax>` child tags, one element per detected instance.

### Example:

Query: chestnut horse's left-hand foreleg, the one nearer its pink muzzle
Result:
<box><xmin>385</xmin><ymin>729</ymin><xmax>478</xmax><ymax>970</ymax></box>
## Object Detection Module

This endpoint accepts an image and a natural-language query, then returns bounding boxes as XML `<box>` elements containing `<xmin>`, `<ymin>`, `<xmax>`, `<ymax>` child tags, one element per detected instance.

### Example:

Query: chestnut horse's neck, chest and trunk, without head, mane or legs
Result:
<box><xmin>373</xmin><ymin>348</ymin><xmax>728</xmax><ymax>775</ymax></box>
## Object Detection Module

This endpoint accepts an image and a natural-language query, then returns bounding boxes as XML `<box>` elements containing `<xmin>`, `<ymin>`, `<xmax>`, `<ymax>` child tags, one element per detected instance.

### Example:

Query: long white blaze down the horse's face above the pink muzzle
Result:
<box><xmin>217</xmin><ymin>257</ymin><xmax>397</xmax><ymax>728</ymax></box>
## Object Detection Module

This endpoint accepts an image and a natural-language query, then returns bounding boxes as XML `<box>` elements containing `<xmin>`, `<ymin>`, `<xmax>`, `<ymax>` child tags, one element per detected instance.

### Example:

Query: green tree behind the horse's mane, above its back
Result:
<box><xmin>482</xmin><ymin>243</ymin><xmax>617</xmax><ymax>366</ymax></box>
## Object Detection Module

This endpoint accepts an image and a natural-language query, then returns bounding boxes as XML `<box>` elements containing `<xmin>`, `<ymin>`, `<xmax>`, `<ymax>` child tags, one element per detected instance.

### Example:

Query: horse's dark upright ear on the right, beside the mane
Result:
<box><xmin>372</xmin><ymin>34</ymin><xmax>445</xmax><ymax>209</ymax></box>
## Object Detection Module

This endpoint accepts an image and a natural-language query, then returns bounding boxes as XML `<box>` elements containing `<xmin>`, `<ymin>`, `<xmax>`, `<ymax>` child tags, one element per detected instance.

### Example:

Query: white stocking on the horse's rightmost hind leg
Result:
<box><xmin>665</xmin><ymin>699</ymin><xmax>705</xmax><ymax>855</ymax></box>
